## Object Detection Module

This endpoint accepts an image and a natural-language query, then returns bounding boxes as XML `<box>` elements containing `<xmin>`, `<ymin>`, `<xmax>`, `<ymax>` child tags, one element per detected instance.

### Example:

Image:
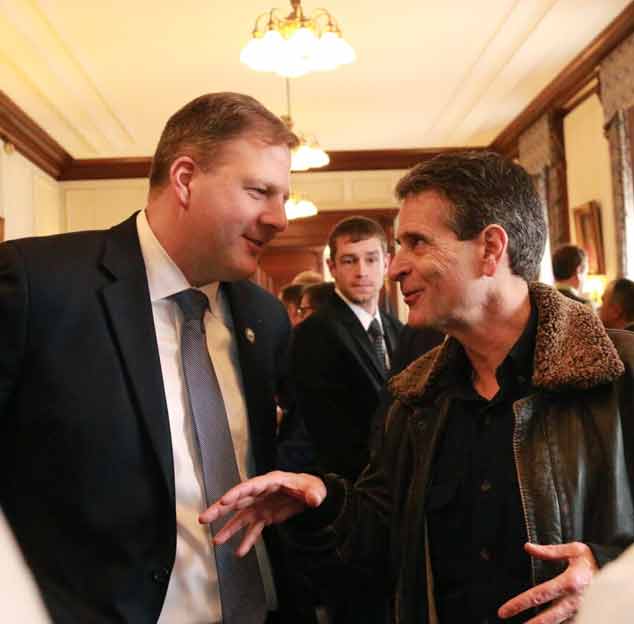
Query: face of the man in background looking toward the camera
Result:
<box><xmin>328</xmin><ymin>236</ymin><xmax>388</xmax><ymax>306</ymax></box>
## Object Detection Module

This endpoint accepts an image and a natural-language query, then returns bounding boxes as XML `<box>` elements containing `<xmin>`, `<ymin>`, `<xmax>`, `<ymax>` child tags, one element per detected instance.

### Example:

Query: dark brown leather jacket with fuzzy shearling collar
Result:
<box><xmin>294</xmin><ymin>284</ymin><xmax>634</xmax><ymax>624</ymax></box>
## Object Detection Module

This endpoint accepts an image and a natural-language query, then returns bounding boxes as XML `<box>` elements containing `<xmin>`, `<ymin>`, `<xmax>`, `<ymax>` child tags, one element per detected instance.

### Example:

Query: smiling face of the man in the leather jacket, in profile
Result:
<box><xmin>390</xmin><ymin>191</ymin><xmax>484</xmax><ymax>331</ymax></box>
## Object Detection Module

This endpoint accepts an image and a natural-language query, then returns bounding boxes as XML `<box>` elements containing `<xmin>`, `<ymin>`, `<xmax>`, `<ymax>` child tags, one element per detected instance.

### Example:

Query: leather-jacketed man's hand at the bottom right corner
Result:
<box><xmin>498</xmin><ymin>542</ymin><xmax>598</xmax><ymax>624</ymax></box>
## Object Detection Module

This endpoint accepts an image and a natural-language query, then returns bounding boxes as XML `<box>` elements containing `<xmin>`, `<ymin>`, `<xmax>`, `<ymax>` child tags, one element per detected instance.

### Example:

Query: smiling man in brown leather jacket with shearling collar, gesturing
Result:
<box><xmin>202</xmin><ymin>152</ymin><xmax>634</xmax><ymax>624</ymax></box>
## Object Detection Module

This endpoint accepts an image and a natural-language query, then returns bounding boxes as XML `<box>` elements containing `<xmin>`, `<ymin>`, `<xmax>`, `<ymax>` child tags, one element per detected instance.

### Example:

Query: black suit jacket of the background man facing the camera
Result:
<box><xmin>290</xmin><ymin>293</ymin><xmax>402</xmax><ymax>480</ymax></box>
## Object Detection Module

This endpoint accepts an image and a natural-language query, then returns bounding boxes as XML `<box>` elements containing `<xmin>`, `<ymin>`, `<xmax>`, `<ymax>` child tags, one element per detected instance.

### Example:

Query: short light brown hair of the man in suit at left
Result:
<box><xmin>150</xmin><ymin>92</ymin><xmax>298</xmax><ymax>190</ymax></box>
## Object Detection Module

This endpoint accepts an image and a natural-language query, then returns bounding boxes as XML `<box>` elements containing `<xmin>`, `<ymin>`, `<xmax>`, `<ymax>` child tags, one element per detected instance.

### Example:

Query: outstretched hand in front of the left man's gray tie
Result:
<box><xmin>198</xmin><ymin>470</ymin><xmax>326</xmax><ymax>557</ymax></box>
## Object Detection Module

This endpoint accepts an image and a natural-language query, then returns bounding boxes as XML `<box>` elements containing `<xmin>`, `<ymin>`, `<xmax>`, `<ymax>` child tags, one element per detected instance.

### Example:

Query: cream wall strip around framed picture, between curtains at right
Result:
<box><xmin>564</xmin><ymin>95</ymin><xmax>617</xmax><ymax>279</ymax></box>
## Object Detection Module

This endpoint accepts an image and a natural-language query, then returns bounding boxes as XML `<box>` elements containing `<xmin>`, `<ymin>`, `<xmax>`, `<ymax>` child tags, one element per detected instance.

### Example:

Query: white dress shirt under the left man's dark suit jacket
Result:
<box><xmin>137</xmin><ymin>211</ymin><xmax>276</xmax><ymax>624</ymax></box>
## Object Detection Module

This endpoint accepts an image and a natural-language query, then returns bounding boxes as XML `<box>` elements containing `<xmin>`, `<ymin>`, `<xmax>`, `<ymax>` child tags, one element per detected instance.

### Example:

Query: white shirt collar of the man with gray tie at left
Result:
<box><xmin>136</xmin><ymin>210</ymin><xmax>219</xmax><ymax>309</ymax></box>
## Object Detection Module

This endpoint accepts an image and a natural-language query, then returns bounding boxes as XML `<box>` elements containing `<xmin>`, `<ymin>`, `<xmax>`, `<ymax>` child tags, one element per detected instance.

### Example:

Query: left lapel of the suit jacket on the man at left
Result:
<box><xmin>96</xmin><ymin>215</ymin><xmax>174</xmax><ymax>499</ymax></box>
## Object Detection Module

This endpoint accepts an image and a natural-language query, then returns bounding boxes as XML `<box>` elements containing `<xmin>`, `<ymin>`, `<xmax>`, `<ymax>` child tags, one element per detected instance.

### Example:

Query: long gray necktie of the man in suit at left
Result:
<box><xmin>170</xmin><ymin>289</ymin><xmax>267</xmax><ymax>624</ymax></box>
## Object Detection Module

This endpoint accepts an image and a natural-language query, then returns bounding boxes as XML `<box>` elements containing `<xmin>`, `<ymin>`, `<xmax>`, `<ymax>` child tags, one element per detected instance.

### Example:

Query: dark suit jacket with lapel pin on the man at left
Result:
<box><xmin>0</xmin><ymin>217</ymin><xmax>289</xmax><ymax>624</ymax></box>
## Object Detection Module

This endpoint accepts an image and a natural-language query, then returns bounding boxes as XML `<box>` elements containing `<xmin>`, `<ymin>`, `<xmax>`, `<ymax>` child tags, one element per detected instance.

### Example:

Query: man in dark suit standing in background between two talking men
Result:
<box><xmin>290</xmin><ymin>217</ymin><xmax>402</xmax><ymax>624</ymax></box>
